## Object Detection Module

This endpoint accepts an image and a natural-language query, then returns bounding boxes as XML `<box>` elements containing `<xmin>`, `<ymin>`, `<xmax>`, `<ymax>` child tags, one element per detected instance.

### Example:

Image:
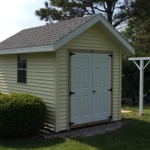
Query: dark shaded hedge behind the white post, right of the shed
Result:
<box><xmin>122</xmin><ymin>52</ymin><xmax>150</xmax><ymax>97</ymax></box>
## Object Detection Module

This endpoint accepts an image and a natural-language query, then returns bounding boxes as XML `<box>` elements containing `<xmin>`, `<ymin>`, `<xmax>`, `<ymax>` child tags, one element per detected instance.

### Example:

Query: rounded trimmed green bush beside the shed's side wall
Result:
<box><xmin>0</xmin><ymin>93</ymin><xmax>46</xmax><ymax>137</ymax></box>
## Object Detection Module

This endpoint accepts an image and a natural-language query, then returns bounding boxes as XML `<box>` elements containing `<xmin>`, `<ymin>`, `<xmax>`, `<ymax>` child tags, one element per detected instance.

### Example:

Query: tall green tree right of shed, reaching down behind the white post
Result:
<box><xmin>121</xmin><ymin>0</ymin><xmax>150</xmax><ymax>96</ymax></box>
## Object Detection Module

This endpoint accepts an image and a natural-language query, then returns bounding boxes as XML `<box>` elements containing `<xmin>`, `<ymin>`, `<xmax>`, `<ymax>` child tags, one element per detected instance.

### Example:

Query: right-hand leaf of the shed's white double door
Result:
<box><xmin>93</xmin><ymin>54</ymin><xmax>111</xmax><ymax>121</ymax></box>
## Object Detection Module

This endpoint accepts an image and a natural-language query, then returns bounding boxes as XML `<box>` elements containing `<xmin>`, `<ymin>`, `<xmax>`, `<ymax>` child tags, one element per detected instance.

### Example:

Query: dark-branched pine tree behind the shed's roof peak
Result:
<box><xmin>35</xmin><ymin>0</ymin><xmax>133</xmax><ymax>27</ymax></box>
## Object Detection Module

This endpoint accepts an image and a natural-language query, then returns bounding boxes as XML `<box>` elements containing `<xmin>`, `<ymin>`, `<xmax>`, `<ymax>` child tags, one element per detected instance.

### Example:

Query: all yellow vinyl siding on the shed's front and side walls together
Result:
<box><xmin>0</xmin><ymin>26</ymin><xmax>122</xmax><ymax>132</ymax></box>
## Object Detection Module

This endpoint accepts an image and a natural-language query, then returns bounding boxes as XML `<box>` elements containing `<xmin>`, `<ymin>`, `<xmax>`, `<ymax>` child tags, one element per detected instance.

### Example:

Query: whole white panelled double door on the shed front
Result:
<box><xmin>71</xmin><ymin>53</ymin><xmax>111</xmax><ymax>125</ymax></box>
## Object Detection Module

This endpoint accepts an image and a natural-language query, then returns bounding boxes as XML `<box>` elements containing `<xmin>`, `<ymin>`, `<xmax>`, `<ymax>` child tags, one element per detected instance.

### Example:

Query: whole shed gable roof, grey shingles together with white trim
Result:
<box><xmin>0</xmin><ymin>14</ymin><xmax>134</xmax><ymax>54</ymax></box>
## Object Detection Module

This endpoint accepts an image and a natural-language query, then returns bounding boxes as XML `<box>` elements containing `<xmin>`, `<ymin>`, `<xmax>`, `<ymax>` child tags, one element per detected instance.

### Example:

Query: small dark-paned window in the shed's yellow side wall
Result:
<box><xmin>17</xmin><ymin>55</ymin><xmax>27</xmax><ymax>83</ymax></box>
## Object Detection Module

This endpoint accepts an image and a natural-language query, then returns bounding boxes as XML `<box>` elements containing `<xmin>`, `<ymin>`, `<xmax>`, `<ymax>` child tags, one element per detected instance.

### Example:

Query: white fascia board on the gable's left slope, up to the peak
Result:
<box><xmin>54</xmin><ymin>15</ymin><xmax>101</xmax><ymax>50</ymax></box>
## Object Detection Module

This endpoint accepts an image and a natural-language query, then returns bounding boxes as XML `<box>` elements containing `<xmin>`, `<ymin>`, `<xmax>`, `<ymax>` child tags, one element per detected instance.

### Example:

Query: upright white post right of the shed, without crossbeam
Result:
<box><xmin>139</xmin><ymin>60</ymin><xmax>144</xmax><ymax>115</ymax></box>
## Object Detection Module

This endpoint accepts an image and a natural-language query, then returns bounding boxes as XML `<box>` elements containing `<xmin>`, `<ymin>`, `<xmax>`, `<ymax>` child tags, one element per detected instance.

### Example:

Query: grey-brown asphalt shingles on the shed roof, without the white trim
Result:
<box><xmin>0</xmin><ymin>15</ymin><xmax>95</xmax><ymax>50</ymax></box>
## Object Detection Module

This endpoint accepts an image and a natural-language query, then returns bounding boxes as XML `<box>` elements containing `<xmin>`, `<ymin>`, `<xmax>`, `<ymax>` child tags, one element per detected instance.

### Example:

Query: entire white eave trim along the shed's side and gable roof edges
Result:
<box><xmin>0</xmin><ymin>14</ymin><xmax>135</xmax><ymax>55</ymax></box>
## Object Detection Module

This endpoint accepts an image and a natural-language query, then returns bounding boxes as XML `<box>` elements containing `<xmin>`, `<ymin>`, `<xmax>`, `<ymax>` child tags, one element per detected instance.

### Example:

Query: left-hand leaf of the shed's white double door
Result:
<box><xmin>71</xmin><ymin>53</ymin><xmax>92</xmax><ymax>125</ymax></box>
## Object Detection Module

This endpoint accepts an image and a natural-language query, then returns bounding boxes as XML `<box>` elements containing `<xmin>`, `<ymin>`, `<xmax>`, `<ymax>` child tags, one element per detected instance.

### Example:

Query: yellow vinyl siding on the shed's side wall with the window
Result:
<box><xmin>0</xmin><ymin>52</ymin><xmax>55</xmax><ymax>130</ymax></box>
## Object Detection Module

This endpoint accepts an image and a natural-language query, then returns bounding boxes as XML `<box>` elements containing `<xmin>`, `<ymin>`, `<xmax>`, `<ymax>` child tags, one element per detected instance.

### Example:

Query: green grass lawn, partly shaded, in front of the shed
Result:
<box><xmin>0</xmin><ymin>106</ymin><xmax>150</xmax><ymax>150</ymax></box>
